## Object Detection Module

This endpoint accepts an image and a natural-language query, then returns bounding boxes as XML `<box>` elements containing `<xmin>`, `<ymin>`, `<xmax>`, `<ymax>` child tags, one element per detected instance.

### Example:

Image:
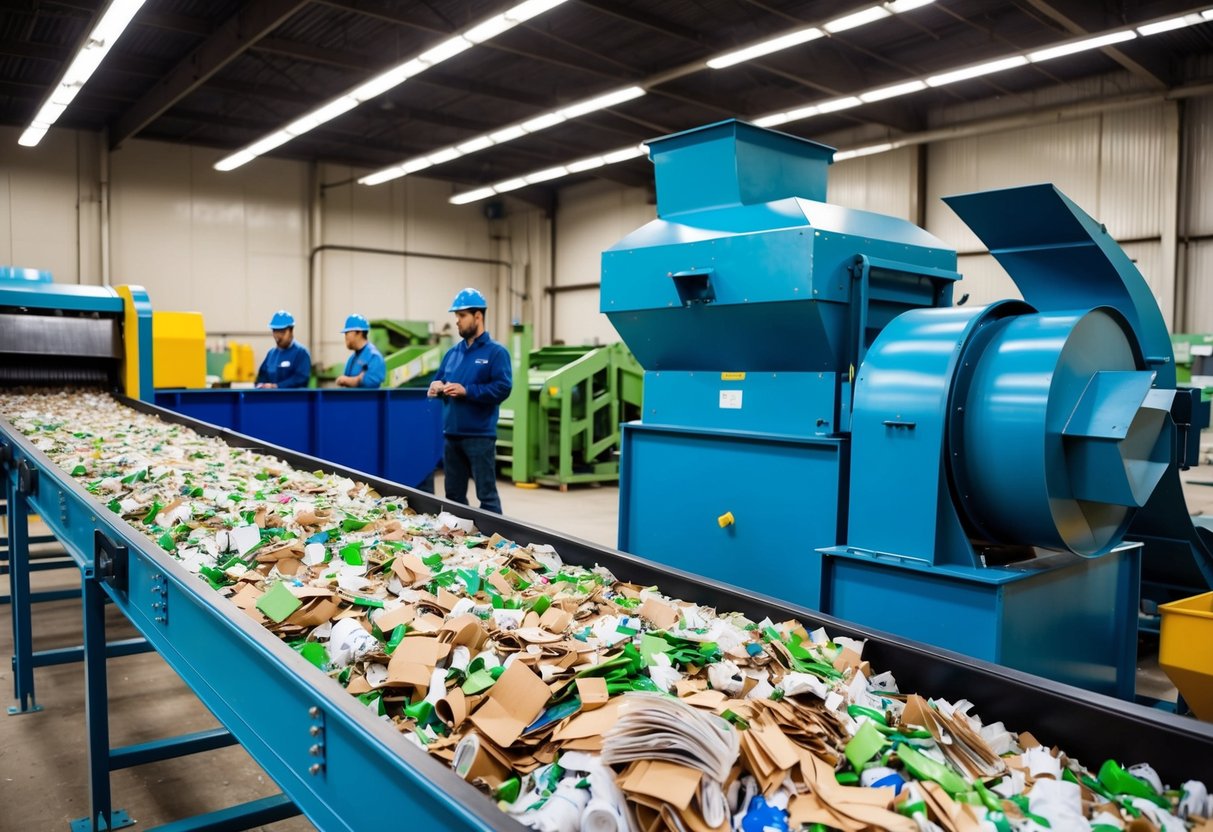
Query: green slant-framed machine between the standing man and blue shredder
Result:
<box><xmin>497</xmin><ymin>324</ymin><xmax>644</xmax><ymax>491</ymax></box>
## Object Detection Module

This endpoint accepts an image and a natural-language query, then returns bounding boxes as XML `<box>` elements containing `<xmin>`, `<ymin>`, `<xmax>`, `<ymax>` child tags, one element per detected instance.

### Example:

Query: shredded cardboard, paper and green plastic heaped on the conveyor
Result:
<box><xmin>0</xmin><ymin>392</ymin><xmax>1213</xmax><ymax>832</ymax></box>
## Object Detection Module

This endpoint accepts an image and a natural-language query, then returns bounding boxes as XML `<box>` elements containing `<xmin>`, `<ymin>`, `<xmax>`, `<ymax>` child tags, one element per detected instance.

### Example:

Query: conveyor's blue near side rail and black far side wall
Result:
<box><xmin>0</xmin><ymin>399</ymin><xmax>1213</xmax><ymax>830</ymax></box>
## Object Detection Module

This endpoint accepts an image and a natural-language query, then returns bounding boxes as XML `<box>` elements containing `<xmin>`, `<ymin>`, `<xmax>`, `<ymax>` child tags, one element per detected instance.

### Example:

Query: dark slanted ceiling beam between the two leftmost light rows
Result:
<box><xmin>109</xmin><ymin>0</ymin><xmax>308</xmax><ymax>149</ymax></box>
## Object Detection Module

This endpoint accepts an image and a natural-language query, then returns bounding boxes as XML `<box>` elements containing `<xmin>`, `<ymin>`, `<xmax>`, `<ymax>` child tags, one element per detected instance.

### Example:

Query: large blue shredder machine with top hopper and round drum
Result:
<box><xmin>611</xmin><ymin>121</ymin><xmax>1213</xmax><ymax>697</ymax></box>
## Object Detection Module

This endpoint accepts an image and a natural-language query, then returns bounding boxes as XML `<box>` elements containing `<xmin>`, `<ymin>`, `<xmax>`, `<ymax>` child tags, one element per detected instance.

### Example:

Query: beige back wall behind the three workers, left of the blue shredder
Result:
<box><xmin>0</xmin><ymin>127</ymin><xmax>551</xmax><ymax>363</ymax></box>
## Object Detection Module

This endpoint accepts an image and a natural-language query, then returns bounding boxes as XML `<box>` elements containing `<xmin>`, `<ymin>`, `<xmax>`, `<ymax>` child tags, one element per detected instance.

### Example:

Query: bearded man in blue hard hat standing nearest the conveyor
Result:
<box><xmin>429</xmin><ymin>289</ymin><xmax>513</xmax><ymax>514</ymax></box>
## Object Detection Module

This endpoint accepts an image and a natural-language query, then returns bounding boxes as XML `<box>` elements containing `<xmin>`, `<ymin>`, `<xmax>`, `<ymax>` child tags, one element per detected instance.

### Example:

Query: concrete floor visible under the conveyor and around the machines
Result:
<box><xmin>0</xmin><ymin>468</ymin><xmax>1213</xmax><ymax>832</ymax></box>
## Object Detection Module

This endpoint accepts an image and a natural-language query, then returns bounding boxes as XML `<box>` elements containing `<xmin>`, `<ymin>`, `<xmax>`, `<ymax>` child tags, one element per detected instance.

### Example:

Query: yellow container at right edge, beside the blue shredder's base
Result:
<box><xmin>1158</xmin><ymin>592</ymin><xmax>1213</xmax><ymax>722</ymax></box>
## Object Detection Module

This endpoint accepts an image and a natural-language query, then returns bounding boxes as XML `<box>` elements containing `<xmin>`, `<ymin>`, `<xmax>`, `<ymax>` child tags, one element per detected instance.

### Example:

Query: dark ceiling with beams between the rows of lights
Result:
<box><xmin>0</xmin><ymin>0</ymin><xmax>1213</xmax><ymax>195</ymax></box>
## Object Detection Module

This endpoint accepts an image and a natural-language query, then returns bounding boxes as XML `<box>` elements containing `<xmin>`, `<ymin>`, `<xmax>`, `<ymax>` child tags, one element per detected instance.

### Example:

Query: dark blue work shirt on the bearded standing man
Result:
<box><xmin>434</xmin><ymin>332</ymin><xmax>513</xmax><ymax>437</ymax></box>
